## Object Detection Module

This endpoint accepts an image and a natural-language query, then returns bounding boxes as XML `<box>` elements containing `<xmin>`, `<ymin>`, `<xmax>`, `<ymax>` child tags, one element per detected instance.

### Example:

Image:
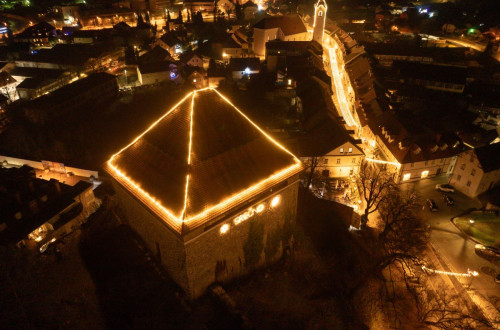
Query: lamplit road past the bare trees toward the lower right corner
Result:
<box><xmin>401</xmin><ymin>176</ymin><xmax>500</xmax><ymax>322</ymax></box>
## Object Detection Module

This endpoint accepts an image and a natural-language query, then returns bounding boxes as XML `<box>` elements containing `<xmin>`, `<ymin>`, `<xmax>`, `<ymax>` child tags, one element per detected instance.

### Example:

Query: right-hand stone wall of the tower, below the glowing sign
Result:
<box><xmin>185</xmin><ymin>179</ymin><xmax>298</xmax><ymax>298</ymax></box>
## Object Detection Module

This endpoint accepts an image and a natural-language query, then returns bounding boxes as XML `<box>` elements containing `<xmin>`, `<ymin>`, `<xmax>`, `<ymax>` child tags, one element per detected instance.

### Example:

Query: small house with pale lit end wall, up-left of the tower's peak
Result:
<box><xmin>137</xmin><ymin>61</ymin><xmax>180</xmax><ymax>85</ymax></box>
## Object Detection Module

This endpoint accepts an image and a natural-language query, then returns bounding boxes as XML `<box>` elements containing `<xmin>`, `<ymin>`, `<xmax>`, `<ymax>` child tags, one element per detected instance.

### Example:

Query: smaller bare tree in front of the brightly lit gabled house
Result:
<box><xmin>356</xmin><ymin>162</ymin><xmax>394</xmax><ymax>229</ymax></box>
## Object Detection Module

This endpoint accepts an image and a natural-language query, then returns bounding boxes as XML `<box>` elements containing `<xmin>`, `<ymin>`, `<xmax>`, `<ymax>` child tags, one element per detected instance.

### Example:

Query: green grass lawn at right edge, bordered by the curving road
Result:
<box><xmin>454</xmin><ymin>211</ymin><xmax>500</xmax><ymax>247</ymax></box>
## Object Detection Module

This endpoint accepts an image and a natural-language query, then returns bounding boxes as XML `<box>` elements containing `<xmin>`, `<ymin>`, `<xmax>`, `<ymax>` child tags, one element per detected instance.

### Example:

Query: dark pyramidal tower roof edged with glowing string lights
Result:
<box><xmin>106</xmin><ymin>88</ymin><xmax>302</xmax><ymax>234</ymax></box>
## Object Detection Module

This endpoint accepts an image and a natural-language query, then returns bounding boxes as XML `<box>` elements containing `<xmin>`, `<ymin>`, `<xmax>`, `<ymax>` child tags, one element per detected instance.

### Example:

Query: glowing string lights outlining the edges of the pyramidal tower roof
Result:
<box><xmin>107</xmin><ymin>87</ymin><xmax>302</xmax><ymax>224</ymax></box>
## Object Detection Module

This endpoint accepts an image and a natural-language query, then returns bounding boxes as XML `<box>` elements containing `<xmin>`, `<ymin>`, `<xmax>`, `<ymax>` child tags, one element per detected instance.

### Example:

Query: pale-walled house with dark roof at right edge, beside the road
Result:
<box><xmin>449</xmin><ymin>143</ymin><xmax>500</xmax><ymax>198</ymax></box>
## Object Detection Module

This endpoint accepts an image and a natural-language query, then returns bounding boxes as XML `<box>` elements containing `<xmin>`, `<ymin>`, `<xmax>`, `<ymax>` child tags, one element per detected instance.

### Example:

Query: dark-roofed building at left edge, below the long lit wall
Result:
<box><xmin>0</xmin><ymin>166</ymin><xmax>100</xmax><ymax>252</ymax></box>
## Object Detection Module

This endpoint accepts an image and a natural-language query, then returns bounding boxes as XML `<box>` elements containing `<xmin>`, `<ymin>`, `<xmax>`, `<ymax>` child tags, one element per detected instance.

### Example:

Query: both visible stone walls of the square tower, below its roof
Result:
<box><xmin>113</xmin><ymin>176</ymin><xmax>298</xmax><ymax>299</ymax></box>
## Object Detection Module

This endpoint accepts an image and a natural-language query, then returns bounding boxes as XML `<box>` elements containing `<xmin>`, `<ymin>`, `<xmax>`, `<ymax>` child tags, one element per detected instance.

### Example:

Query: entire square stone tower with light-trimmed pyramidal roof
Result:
<box><xmin>106</xmin><ymin>89</ymin><xmax>302</xmax><ymax>298</ymax></box>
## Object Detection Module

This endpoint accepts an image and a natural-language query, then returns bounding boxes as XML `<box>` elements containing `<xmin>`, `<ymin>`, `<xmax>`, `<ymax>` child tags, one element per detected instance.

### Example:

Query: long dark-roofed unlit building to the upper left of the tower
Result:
<box><xmin>20</xmin><ymin>72</ymin><xmax>118</xmax><ymax>124</ymax></box>
